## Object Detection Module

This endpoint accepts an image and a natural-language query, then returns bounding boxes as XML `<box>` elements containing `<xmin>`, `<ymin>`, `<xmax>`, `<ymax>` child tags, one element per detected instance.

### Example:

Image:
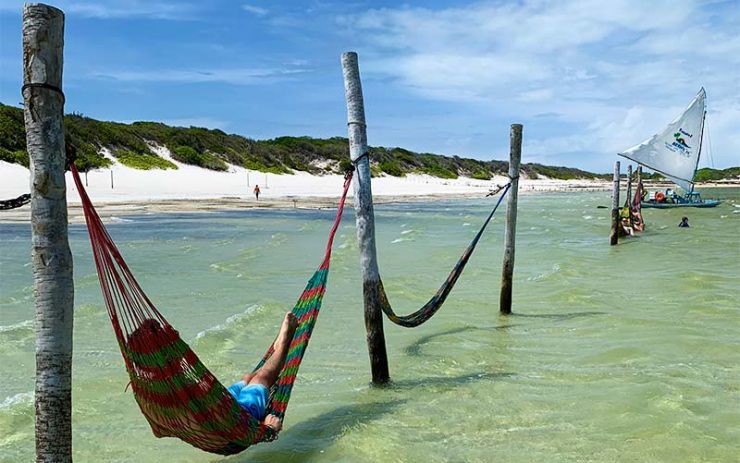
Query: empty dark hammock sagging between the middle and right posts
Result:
<box><xmin>377</xmin><ymin>183</ymin><xmax>511</xmax><ymax>328</ymax></box>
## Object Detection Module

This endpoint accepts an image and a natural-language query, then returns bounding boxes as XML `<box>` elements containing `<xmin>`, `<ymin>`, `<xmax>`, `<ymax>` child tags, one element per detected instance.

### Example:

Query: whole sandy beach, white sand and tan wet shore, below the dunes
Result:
<box><xmin>0</xmin><ymin>148</ymin><xmax>611</xmax><ymax>223</ymax></box>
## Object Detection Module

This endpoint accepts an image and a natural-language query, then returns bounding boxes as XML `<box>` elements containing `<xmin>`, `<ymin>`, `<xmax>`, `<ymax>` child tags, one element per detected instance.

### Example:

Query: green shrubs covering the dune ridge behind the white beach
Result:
<box><xmin>0</xmin><ymin>103</ymin><xmax>740</xmax><ymax>181</ymax></box>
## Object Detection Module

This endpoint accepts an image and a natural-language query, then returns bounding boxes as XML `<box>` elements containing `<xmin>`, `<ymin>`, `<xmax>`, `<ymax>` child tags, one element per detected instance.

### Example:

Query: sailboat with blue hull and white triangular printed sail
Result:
<box><xmin>618</xmin><ymin>88</ymin><xmax>720</xmax><ymax>209</ymax></box>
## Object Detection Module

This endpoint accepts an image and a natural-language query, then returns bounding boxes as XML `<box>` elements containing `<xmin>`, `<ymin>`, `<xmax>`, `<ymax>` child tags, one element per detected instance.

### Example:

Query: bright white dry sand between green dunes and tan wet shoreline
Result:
<box><xmin>0</xmin><ymin>147</ymin><xmax>607</xmax><ymax>204</ymax></box>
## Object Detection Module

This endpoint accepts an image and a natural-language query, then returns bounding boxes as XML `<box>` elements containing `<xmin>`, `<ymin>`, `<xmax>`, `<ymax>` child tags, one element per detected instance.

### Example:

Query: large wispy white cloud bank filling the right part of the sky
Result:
<box><xmin>339</xmin><ymin>0</ymin><xmax>740</xmax><ymax>170</ymax></box>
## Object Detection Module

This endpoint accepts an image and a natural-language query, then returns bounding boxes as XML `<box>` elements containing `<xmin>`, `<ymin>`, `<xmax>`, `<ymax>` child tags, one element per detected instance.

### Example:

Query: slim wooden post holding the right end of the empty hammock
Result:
<box><xmin>499</xmin><ymin>124</ymin><xmax>522</xmax><ymax>315</ymax></box>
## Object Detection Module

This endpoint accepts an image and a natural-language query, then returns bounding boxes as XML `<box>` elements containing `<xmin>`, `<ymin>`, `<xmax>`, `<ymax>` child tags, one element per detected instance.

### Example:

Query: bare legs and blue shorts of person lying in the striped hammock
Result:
<box><xmin>228</xmin><ymin>312</ymin><xmax>298</xmax><ymax>431</ymax></box>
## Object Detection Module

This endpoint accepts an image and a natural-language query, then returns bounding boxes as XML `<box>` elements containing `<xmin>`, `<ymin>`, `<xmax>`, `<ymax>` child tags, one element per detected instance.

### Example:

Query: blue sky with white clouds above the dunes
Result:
<box><xmin>0</xmin><ymin>0</ymin><xmax>740</xmax><ymax>172</ymax></box>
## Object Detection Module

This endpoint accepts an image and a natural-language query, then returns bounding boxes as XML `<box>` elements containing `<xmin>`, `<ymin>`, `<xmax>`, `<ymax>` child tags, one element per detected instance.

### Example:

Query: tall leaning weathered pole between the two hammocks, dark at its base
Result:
<box><xmin>342</xmin><ymin>52</ymin><xmax>390</xmax><ymax>384</ymax></box>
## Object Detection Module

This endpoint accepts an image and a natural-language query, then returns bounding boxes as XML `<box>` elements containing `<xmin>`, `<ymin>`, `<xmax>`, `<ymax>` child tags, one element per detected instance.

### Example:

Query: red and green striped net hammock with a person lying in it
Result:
<box><xmin>70</xmin><ymin>164</ymin><xmax>352</xmax><ymax>455</ymax></box>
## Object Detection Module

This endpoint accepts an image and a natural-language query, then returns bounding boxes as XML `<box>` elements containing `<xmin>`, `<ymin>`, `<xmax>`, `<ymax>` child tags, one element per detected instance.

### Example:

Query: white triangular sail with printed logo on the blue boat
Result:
<box><xmin>619</xmin><ymin>88</ymin><xmax>706</xmax><ymax>191</ymax></box>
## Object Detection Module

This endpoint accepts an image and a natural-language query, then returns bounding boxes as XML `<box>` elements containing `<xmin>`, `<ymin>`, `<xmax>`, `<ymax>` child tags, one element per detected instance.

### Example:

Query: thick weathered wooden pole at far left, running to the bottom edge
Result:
<box><xmin>22</xmin><ymin>4</ymin><xmax>74</xmax><ymax>462</ymax></box>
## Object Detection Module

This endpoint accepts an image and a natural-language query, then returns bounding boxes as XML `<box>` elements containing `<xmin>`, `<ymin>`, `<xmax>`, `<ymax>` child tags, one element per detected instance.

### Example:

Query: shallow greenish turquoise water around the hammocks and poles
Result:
<box><xmin>0</xmin><ymin>189</ymin><xmax>740</xmax><ymax>462</ymax></box>
